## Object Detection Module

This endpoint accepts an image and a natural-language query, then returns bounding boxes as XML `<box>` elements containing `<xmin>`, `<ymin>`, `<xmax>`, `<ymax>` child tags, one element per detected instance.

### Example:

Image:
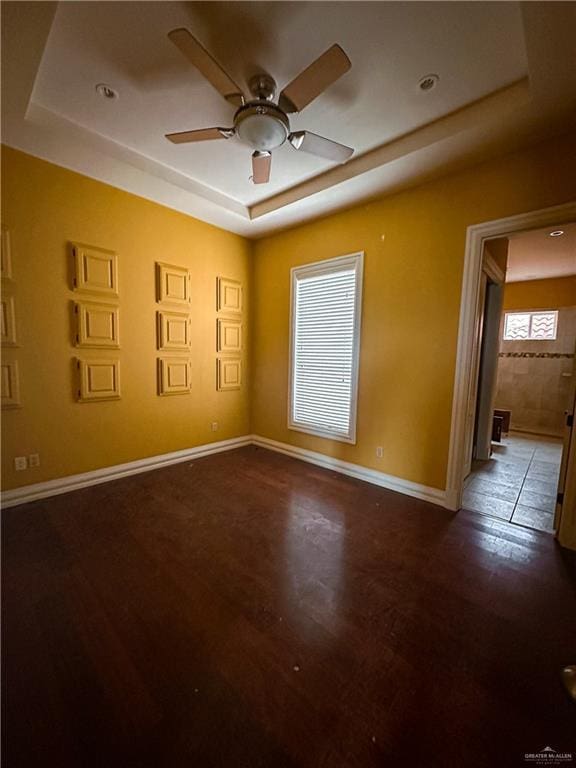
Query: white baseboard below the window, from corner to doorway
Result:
<box><xmin>252</xmin><ymin>435</ymin><xmax>452</xmax><ymax>509</ymax></box>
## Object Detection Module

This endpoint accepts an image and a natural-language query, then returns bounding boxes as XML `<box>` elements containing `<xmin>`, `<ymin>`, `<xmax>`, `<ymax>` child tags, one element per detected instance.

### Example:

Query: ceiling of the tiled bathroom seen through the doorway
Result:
<box><xmin>506</xmin><ymin>222</ymin><xmax>576</xmax><ymax>284</ymax></box>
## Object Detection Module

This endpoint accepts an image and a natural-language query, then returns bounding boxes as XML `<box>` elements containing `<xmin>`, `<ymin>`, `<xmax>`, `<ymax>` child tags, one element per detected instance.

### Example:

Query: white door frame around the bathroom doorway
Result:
<box><xmin>446</xmin><ymin>201</ymin><xmax>576</xmax><ymax>511</ymax></box>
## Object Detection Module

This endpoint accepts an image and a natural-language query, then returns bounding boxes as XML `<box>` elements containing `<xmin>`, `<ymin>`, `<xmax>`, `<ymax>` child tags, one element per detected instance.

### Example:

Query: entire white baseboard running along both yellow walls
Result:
<box><xmin>1</xmin><ymin>435</ymin><xmax>453</xmax><ymax>509</ymax></box>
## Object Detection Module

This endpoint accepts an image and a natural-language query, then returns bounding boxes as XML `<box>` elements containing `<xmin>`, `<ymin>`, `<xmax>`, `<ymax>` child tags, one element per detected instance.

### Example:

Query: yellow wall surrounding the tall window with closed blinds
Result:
<box><xmin>252</xmin><ymin>137</ymin><xmax>576</xmax><ymax>488</ymax></box>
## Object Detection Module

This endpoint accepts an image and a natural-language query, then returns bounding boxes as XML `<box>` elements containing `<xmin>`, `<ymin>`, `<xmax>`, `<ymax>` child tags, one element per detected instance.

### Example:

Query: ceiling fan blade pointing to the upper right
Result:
<box><xmin>278</xmin><ymin>44</ymin><xmax>352</xmax><ymax>112</ymax></box>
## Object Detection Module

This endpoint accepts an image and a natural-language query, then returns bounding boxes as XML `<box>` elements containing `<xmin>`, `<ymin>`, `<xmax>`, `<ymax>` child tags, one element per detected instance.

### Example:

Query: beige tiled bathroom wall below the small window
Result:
<box><xmin>496</xmin><ymin>306</ymin><xmax>576</xmax><ymax>436</ymax></box>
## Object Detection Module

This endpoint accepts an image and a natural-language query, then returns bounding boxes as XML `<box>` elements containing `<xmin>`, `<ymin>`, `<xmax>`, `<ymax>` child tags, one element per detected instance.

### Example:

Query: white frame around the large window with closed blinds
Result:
<box><xmin>288</xmin><ymin>251</ymin><xmax>364</xmax><ymax>445</ymax></box>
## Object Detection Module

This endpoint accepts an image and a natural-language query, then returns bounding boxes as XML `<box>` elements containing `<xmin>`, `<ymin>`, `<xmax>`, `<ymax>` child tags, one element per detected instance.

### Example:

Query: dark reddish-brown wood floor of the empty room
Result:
<box><xmin>3</xmin><ymin>448</ymin><xmax>576</xmax><ymax>768</ymax></box>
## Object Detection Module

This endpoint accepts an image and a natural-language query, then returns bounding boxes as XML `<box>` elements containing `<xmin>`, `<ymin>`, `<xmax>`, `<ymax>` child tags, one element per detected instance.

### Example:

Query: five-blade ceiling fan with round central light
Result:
<box><xmin>166</xmin><ymin>28</ymin><xmax>354</xmax><ymax>184</ymax></box>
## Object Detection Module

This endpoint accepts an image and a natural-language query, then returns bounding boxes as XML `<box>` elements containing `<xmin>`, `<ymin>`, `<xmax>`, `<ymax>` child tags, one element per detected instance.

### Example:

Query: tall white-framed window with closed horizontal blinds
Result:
<box><xmin>288</xmin><ymin>253</ymin><xmax>363</xmax><ymax>443</ymax></box>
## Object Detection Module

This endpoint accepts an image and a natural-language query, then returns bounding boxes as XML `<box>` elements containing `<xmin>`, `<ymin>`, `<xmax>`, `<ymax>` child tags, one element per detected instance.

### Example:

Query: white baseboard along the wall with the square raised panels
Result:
<box><xmin>1</xmin><ymin>435</ymin><xmax>252</xmax><ymax>508</ymax></box>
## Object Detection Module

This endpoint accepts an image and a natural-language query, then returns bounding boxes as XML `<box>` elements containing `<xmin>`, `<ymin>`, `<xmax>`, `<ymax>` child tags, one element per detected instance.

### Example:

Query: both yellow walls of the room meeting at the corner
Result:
<box><xmin>2</xmin><ymin>133</ymin><xmax>576</xmax><ymax>496</ymax></box>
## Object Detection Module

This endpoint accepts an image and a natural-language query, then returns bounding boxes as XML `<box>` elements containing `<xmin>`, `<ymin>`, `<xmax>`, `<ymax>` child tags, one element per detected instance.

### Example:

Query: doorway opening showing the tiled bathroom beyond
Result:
<box><xmin>462</xmin><ymin>222</ymin><xmax>576</xmax><ymax>533</ymax></box>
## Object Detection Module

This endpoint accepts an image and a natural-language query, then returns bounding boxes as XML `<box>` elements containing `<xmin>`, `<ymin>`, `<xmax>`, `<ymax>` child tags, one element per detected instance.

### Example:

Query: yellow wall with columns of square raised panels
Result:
<box><xmin>2</xmin><ymin>147</ymin><xmax>251</xmax><ymax>489</ymax></box>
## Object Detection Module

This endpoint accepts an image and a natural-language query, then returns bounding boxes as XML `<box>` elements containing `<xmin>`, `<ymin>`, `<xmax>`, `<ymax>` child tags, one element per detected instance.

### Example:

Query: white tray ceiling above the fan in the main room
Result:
<box><xmin>2</xmin><ymin>2</ymin><xmax>576</xmax><ymax>236</ymax></box>
